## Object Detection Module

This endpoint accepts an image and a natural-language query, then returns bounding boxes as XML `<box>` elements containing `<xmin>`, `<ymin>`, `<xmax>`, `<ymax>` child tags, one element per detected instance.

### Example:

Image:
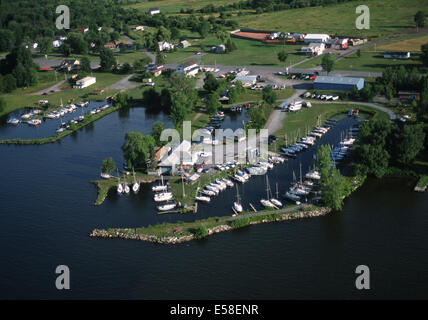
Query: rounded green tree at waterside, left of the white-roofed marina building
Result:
<box><xmin>122</xmin><ymin>132</ymin><xmax>155</xmax><ymax>171</ymax></box>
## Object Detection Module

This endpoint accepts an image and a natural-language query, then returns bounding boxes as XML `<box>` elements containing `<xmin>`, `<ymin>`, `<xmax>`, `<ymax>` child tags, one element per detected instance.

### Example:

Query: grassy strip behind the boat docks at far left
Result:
<box><xmin>0</xmin><ymin>72</ymin><xmax>126</xmax><ymax>116</ymax></box>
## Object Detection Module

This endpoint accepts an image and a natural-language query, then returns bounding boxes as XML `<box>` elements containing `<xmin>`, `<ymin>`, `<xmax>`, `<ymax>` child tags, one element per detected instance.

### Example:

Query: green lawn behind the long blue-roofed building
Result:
<box><xmin>334</xmin><ymin>51</ymin><xmax>422</xmax><ymax>72</ymax></box>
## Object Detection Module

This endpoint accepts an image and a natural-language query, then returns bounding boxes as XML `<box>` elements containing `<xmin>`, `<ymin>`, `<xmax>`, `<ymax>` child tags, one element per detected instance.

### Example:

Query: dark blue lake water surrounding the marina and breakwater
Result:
<box><xmin>0</xmin><ymin>108</ymin><xmax>428</xmax><ymax>299</ymax></box>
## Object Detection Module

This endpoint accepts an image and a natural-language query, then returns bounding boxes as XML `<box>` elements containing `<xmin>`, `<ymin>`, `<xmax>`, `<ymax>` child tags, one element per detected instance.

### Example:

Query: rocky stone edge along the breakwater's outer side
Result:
<box><xmin>90</xmin><ymin>207</ymin><xmax>332</xmax><ymax>244</ymax></box>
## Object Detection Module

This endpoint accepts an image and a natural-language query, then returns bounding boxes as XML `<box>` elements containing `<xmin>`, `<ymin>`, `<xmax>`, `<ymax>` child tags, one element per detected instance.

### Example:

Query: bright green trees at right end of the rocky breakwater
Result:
<box><xmin>317</xmin><ymin>145</ymin><xmax>350</xmax><ymax>210</ymax></box>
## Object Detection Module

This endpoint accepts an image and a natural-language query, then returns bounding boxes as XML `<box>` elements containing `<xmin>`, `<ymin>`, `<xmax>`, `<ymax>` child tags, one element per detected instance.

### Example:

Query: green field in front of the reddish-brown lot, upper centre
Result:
<box><xmin>202</xmin><ymin>39</ymin><xmax>307</xmax><ymax>67</ymax></box>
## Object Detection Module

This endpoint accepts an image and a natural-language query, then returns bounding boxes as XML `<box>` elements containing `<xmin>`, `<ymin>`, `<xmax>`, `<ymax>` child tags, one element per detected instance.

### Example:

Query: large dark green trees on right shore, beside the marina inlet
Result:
<box><xmin>354</xmin><ymin>119</ymin><xmax>425</xmax><ymax>178</ymax></box>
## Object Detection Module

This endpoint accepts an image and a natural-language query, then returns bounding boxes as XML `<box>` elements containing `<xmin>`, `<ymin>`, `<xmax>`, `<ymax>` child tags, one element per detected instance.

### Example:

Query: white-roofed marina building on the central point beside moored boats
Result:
<box><xmin>158</xmin><ymin>140</ymin><xmax>198</xmax><ymax>174</ymax></box>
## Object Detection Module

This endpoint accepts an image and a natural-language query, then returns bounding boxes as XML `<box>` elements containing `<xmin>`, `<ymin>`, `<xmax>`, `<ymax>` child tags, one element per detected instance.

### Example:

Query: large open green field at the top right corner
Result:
<box><xmin>233</xmin><ymin>0</ymin><xmax>428</xmax><ymax>37</ymax></box>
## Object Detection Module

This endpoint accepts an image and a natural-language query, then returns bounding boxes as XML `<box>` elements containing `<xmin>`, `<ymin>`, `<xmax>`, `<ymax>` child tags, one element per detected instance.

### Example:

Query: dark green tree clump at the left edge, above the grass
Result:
<box><xmin>0</xmin><ymin>46</ymin><xmax>39</xmax><ymax>93</ymax></box>
